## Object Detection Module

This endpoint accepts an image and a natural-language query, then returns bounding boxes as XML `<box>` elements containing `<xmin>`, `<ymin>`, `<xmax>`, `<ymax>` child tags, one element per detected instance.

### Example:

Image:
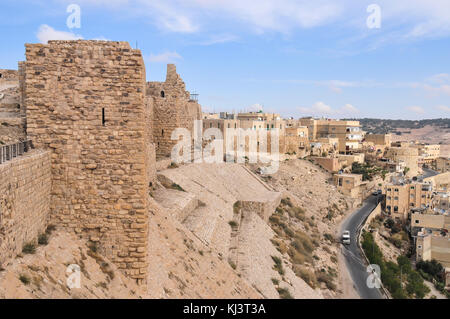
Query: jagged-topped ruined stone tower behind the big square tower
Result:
<box><xmin>146</xmin><ymin>64</ymin><xmax>202</xmax><ymax>159</ymax></box>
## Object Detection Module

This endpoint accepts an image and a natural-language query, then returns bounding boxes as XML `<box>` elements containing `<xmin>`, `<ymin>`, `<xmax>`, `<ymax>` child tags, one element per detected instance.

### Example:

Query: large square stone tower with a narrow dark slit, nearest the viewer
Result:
<box><xmin>25</xmin><ymin>41</ymin><xmax>151</xmax><ymax>282</ymax></box>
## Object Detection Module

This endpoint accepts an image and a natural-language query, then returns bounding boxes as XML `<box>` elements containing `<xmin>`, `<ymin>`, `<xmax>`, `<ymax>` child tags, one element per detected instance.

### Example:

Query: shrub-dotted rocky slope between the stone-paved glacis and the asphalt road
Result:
<box><xmin>248</xmin><ymin>159</ymin><xmax>356</xmax><ymax>298</ymax></box>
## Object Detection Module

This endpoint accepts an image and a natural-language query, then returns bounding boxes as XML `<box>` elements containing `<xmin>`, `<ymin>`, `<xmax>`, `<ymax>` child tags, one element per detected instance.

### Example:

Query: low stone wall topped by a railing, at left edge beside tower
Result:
<box><xmin>0</xmin><ymin>150</ymin><xmax>51</xmax><ymax>266</ymax></box>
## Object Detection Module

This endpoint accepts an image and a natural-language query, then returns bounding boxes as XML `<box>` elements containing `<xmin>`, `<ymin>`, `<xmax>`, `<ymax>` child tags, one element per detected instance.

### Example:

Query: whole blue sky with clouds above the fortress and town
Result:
<box><xmin>0</xmin><ymin>0</ymin><xmax>450</xmax><ymax>119</ymax></box>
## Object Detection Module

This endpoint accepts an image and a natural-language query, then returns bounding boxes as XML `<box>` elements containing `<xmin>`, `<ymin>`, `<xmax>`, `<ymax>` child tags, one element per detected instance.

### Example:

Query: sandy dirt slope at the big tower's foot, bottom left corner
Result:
<box><xmin>0</xmin><ymin>230</ymin><xmax>146</xmax><ymax>299</ymax></box>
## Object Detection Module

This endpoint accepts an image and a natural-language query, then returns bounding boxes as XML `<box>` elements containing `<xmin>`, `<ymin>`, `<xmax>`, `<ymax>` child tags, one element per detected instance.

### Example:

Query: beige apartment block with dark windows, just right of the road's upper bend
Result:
<box><xmin>383</xmin><ymin>182</ymin><xmax>433</xmax><ymax>222</ymax></box>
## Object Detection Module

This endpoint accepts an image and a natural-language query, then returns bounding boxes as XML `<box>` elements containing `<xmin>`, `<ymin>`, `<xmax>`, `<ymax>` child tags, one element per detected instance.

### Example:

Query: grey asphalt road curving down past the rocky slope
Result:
<box><xmin>340</xmin><ymin>195</ymin><xmax>384</xmax><ymax>299</ymax></box>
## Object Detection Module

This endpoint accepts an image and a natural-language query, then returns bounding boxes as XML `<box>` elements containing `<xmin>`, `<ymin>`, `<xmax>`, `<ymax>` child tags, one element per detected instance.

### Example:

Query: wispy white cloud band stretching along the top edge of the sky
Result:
<box><xmin>60</xmin><ymin>0</ymin><xmax>450</xmax><ymax>44</ymax></box>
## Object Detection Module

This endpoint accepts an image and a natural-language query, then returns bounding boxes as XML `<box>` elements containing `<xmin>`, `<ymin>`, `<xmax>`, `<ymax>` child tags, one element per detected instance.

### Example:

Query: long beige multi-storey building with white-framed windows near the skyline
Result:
<box><xmin>300</xmin><ymin>118</ymin><xmax>364</xmax><ymax>153</ymax></box>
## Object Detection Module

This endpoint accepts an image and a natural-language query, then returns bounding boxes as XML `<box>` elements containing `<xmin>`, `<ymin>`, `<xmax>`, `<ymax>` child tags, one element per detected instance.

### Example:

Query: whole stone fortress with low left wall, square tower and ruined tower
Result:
<box><xmin>0</xmin><ymin>40</ymin><xmax>201</xmax><ymax>282</ymax></box>
